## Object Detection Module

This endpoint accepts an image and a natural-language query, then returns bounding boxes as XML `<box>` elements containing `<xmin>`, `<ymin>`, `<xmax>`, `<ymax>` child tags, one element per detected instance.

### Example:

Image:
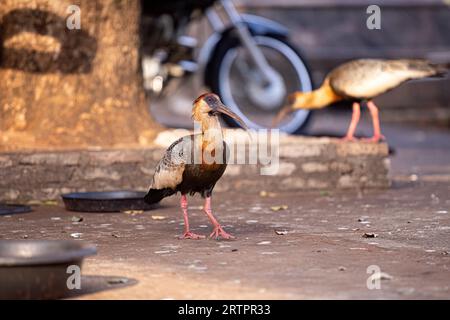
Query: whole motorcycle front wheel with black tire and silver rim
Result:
<box><xmin>207</xmin><ymin>35</ymin><xmax>313</xmax><ymax>134</ymax></box>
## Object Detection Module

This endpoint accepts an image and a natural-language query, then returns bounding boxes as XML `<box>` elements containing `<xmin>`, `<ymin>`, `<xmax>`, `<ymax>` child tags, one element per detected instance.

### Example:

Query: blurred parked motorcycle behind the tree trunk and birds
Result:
<box><xmin>141</xmin><ymin>0</ymin><xmax>312</xmax><ymax>133</ymax></box>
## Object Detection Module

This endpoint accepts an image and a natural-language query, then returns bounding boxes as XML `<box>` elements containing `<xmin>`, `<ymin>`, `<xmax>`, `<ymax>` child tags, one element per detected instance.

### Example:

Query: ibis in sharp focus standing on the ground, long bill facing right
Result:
<box><xmin>145</xmin><ymin>93</ymin><xmax>247</xmax><ymax>239</ymax></box>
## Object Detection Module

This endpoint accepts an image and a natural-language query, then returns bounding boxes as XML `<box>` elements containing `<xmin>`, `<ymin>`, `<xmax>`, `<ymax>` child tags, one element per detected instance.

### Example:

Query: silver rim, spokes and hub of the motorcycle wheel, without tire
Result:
<box><xmin>218</xmin><ymin>36</ymin><xmax>312</xmax><ymax>133</ymax></box>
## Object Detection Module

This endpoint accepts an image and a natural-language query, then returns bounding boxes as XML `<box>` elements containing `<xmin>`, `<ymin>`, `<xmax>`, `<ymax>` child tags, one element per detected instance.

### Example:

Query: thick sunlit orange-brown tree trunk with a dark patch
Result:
<box><xmin>0</xmin><ymin>0</ymin><xmax>159</xmax><ymax>150</ymax></box>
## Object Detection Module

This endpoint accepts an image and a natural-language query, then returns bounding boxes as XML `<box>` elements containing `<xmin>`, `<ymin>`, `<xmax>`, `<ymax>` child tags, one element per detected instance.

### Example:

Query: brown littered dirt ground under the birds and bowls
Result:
<box><xmin>0</xmin><ymin>109</ymin><xmax>450</xmax><ymax>299</ymax></box>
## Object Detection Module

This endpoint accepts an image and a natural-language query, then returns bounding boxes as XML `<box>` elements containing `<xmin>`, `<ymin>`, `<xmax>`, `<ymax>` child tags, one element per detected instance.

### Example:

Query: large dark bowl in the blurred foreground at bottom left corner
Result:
<box><xmin>0</xmin><ymin>240</ymin><xmax>97</xmax><ymax>299</ymax></box>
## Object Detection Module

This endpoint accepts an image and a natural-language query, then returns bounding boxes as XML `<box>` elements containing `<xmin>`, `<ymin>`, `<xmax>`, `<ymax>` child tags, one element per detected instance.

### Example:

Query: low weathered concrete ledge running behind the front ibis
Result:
<box><xmin>0</xmin><ymin>130</ymin><xmax>389</xmax><ymax>201</ymax></box>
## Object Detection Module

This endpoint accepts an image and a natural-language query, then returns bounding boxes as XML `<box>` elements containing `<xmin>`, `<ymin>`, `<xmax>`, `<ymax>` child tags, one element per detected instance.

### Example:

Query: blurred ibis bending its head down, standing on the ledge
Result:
<box><xmin>274</xmin><ymin>59</ymin><xmax>450</xmax><ymax>142</ymax></box>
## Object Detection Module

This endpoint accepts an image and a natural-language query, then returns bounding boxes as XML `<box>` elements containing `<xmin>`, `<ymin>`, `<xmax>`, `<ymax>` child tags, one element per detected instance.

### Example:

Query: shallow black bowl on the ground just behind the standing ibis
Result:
<box><xmin>61</xmin><ymin>191</ymin><xmax>156</xmax><ymax>212</ymax></box>
